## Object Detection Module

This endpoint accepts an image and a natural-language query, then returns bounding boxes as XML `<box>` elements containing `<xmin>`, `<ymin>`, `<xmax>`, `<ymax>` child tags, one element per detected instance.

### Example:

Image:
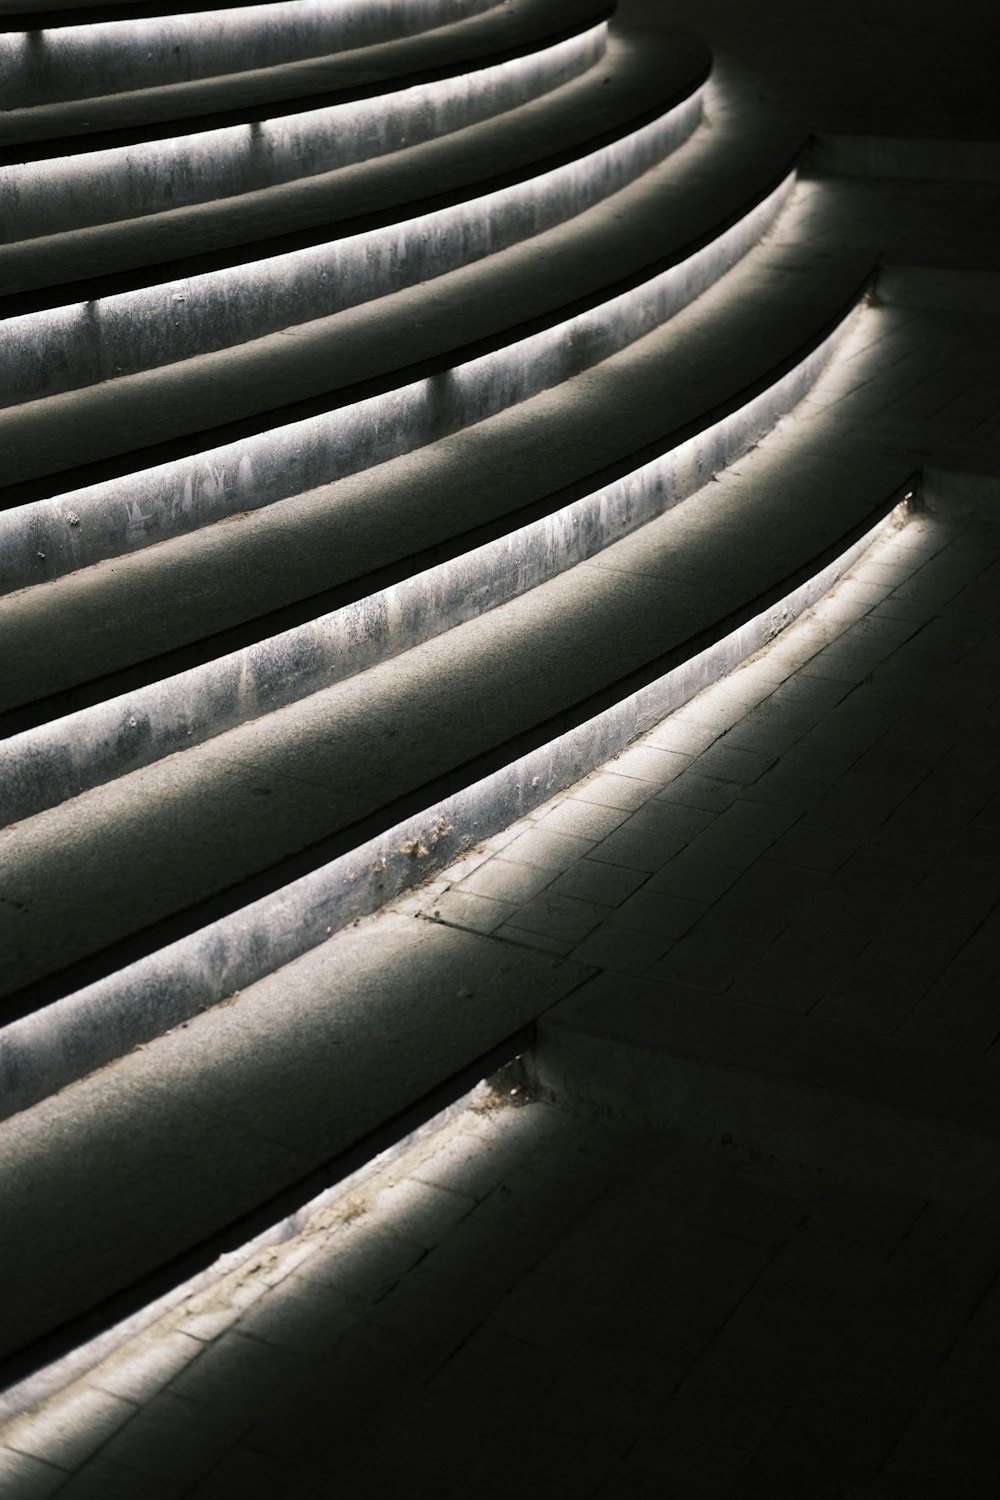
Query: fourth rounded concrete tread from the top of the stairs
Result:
<box><xmin>0</xmin><ymin>202</ymin><xmax>864</xmax><ymax>732</ymax></box>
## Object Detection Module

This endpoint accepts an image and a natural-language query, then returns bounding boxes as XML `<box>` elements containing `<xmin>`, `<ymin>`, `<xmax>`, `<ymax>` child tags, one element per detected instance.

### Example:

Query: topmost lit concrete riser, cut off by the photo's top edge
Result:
<box><xmin>0</xmin><ymin>0</ymin><xmax>495</xmax><ymax>110</ymax></box>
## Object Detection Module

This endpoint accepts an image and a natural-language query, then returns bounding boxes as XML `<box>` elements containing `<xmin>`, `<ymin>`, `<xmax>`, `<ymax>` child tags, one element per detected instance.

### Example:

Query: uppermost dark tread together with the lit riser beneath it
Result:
<box><xmin>0</xmin><ymin>0</ymin><xmax>607</xmax><ymax>228</ymax></box>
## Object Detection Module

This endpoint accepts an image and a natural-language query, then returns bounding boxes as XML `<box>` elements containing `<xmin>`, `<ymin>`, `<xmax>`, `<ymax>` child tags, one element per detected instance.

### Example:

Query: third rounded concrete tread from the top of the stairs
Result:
<box><xmin>0</xmin><ymin>102</ymin><xmax>796</xmax><ymax>588</ymax></box>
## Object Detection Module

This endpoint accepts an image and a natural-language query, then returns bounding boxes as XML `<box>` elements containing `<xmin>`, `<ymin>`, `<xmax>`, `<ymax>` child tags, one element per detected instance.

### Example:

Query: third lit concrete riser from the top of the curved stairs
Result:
<box><xmin>0</xmin><ymin>70</ymin><xmax>703</xmax><ymax>407</ymax></box>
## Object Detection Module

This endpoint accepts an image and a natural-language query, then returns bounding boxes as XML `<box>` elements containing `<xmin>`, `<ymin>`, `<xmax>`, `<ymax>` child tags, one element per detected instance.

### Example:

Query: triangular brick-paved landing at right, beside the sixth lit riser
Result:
<box><xmin>437</xmin><ymin>504</ymin><xmax>1000</xmax><ymax>1050</ymax></box>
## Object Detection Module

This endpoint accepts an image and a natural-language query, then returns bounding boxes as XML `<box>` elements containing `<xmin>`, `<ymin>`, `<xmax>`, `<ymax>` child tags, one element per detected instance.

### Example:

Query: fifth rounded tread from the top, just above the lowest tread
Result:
<box><xmin>0</xmin><ymin>411</ymin><xmax>906</xmax><ymax>1020</ymax></box>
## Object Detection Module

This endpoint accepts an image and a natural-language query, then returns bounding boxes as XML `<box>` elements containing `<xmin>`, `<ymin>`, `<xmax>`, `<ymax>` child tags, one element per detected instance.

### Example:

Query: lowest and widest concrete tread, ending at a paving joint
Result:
<box><xmin>0</xmin><ymin>915</ymin><xmax>586</xmax><ymax>1374</ymax></box>
